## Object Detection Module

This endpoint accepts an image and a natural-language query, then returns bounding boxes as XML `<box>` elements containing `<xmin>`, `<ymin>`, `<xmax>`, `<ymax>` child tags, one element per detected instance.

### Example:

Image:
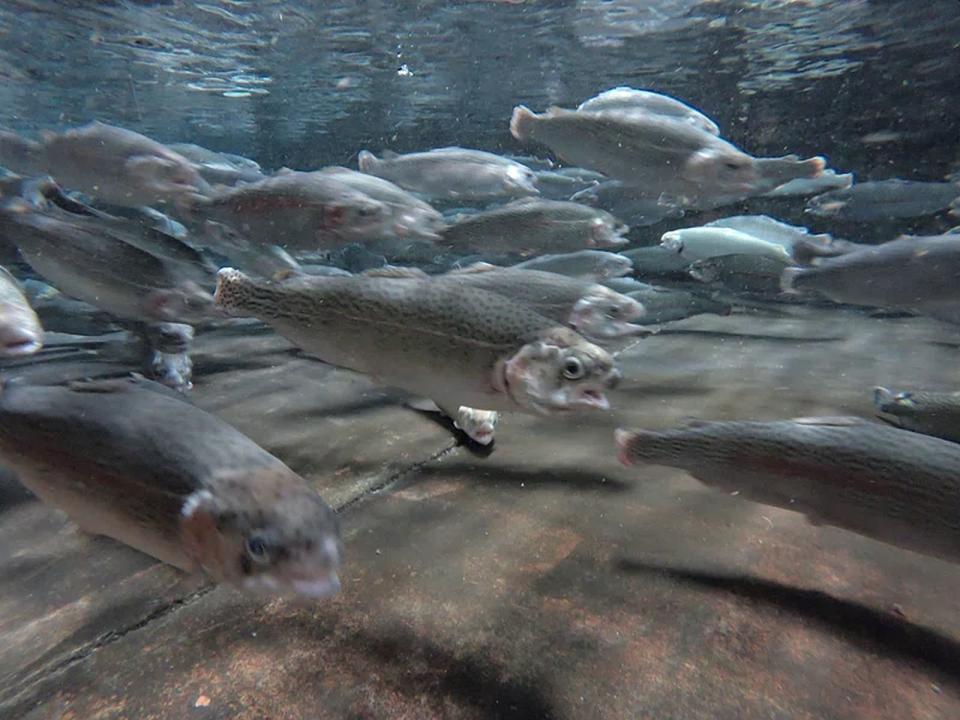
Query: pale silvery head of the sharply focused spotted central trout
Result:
<box><xmin>498</xmin><ymin>327</ymin><xmax>620</xmax><ymax>415</ymax></box>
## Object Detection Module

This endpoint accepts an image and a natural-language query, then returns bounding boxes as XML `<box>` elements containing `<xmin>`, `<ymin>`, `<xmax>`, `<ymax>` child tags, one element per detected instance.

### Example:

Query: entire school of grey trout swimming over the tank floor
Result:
<box><xmin>0</xmin><ymin>87</ymin><xmax>960</xmax><ymax>599</ymax></box>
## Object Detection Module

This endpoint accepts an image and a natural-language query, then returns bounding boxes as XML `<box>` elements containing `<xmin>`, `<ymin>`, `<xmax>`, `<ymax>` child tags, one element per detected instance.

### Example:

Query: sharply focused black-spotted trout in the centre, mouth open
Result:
<box><xmin>215</xmin><ymin>268</ymin><xmax>620</xmax><ymax>416</ymax></box>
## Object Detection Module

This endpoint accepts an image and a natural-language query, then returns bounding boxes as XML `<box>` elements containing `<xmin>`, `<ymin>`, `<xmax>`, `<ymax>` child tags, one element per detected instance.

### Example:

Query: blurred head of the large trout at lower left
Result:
<box><xmin>180</xmin><ymin>468</ymin><xmax>343</xmax><ymax>599</ymax></box>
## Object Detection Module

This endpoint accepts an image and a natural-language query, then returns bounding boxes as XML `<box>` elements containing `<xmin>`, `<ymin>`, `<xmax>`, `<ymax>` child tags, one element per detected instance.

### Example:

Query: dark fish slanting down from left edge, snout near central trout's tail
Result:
<box><xmin>0</xmin><ymin>199</ymin><xmax>216</xmax><ymax>322</ymax></box>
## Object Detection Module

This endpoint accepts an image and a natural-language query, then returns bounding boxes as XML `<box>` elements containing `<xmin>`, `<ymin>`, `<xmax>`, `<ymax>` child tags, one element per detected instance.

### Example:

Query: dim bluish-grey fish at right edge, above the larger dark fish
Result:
<box><xmin>805</xmin><ymin>179</ymin><xmax>960</xmax><ymax>222</ymax></box>
